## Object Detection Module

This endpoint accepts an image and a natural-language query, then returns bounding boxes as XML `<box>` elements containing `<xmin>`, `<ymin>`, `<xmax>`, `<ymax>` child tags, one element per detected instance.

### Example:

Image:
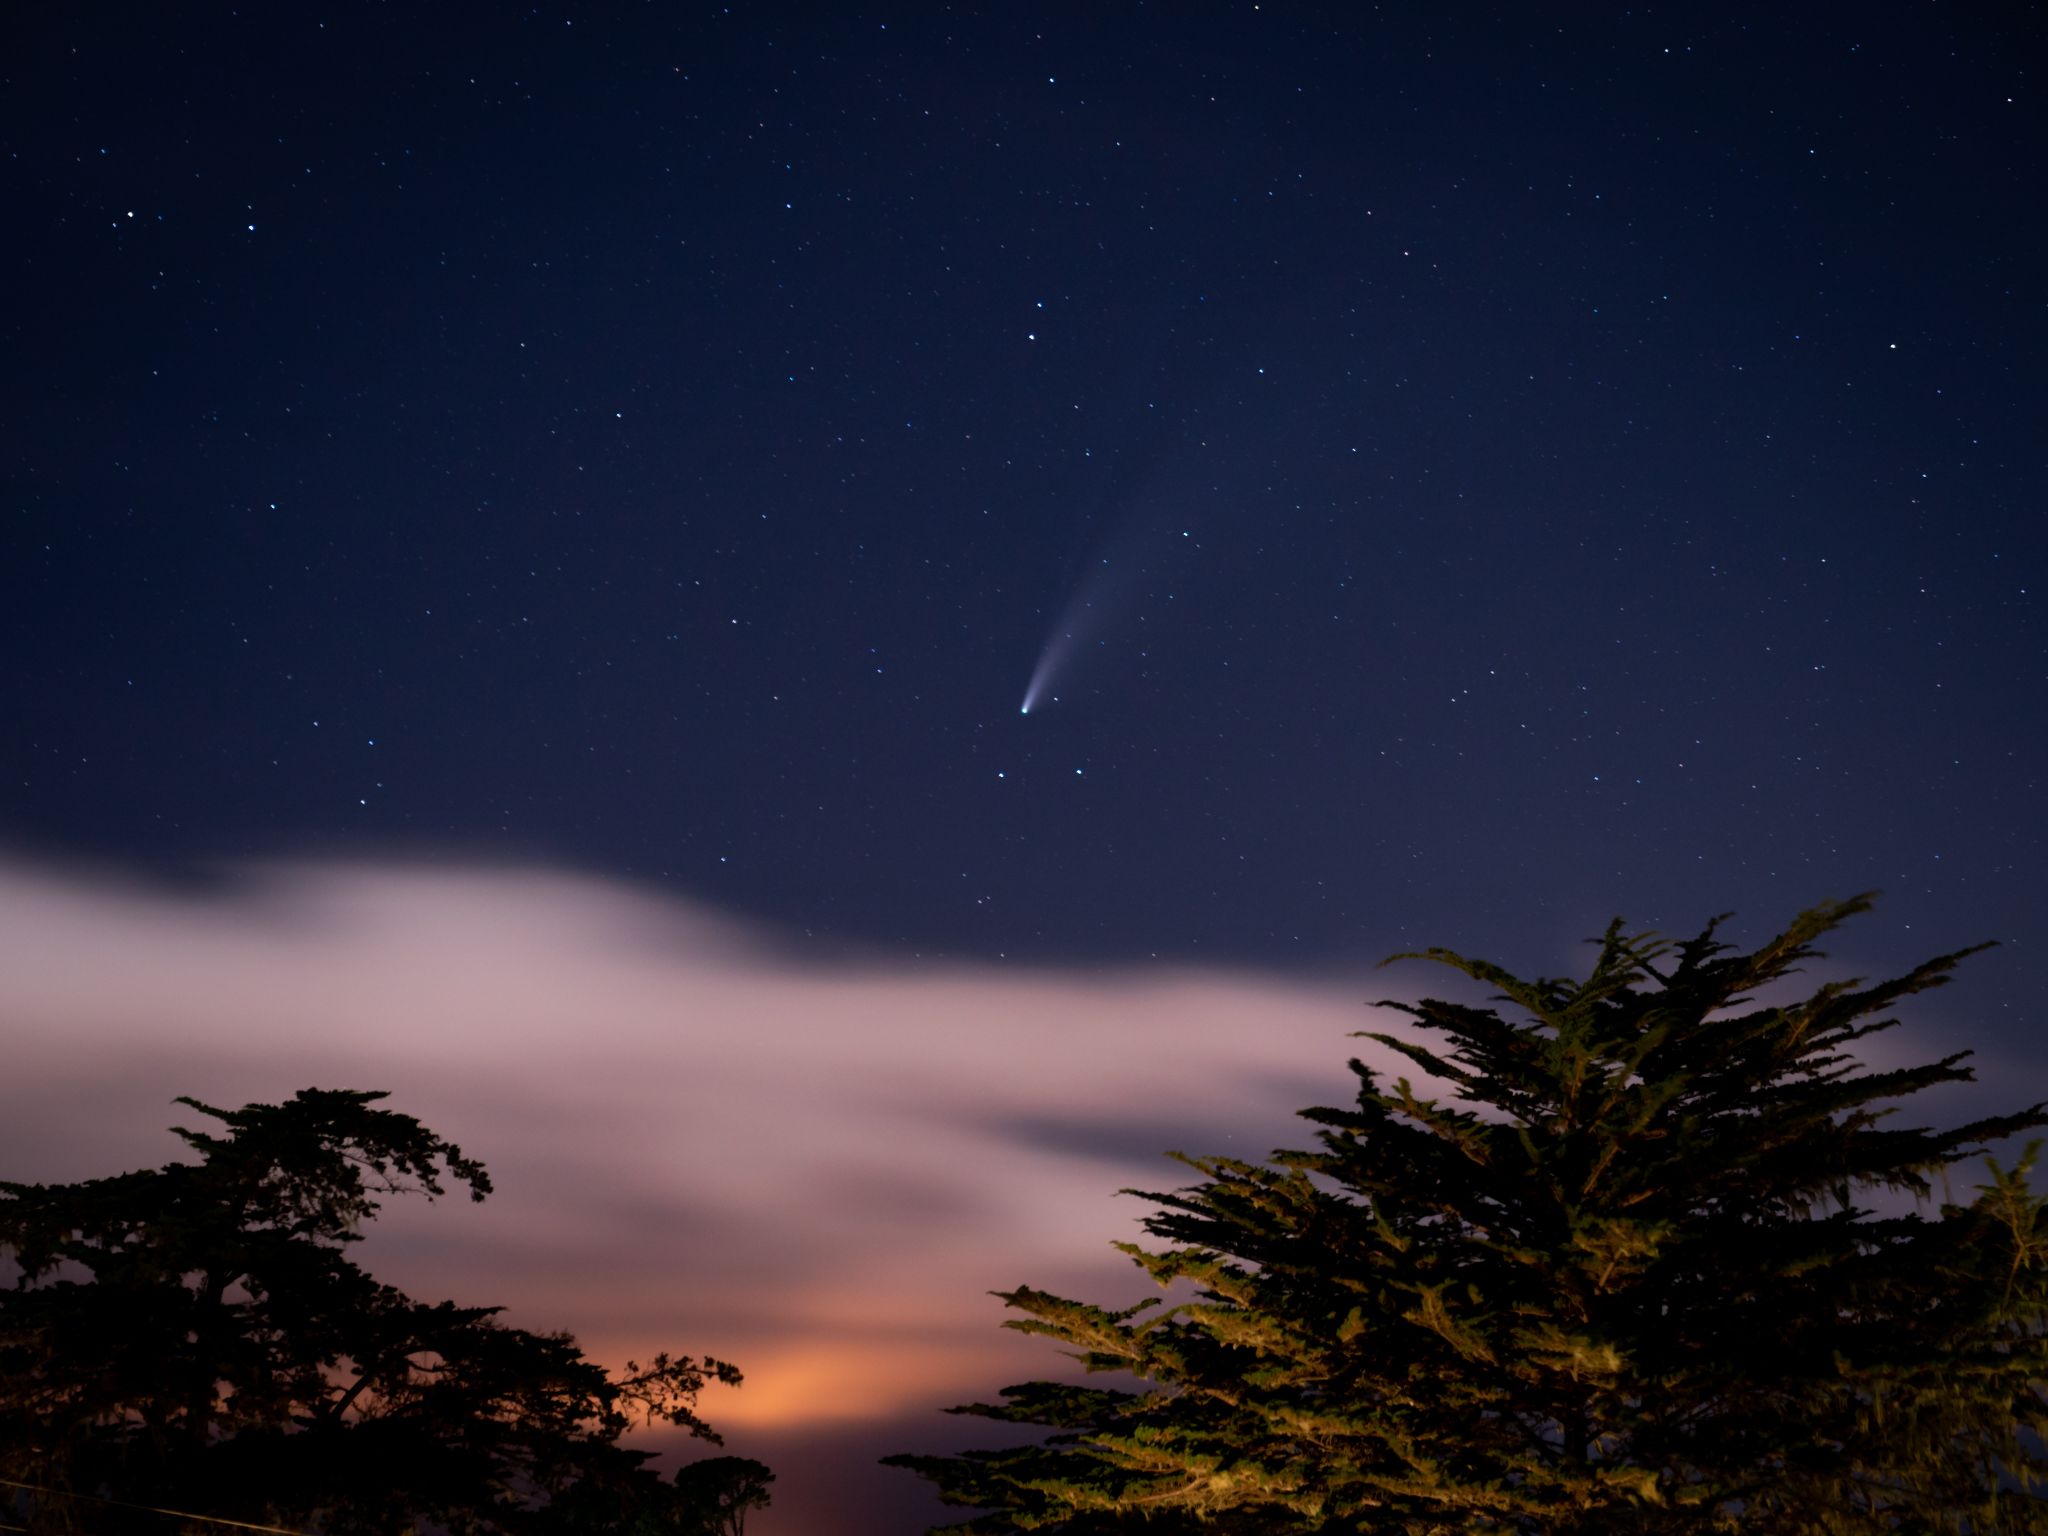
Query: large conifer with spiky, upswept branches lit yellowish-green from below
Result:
<box><xmin>891</xmin><ymin>897</ymin><xmax>2048</xmax><ymax>1536</ymax></box>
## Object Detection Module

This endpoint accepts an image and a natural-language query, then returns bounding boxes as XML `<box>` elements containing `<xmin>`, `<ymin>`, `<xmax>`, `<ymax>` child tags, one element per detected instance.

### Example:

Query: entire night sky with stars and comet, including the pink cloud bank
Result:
<box><xmin>0</xmin><ymin>4</ymin><xmax>2048</xmax><ymax>1536</ymax></box>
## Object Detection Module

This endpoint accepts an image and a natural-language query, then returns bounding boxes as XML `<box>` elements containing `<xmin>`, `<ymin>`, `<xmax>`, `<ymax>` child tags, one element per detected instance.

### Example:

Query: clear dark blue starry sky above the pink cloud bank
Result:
<box><xmin>0</xmin><ymin>4</ymin><xmax>2048</xmax><ymax>1531</ymax></box>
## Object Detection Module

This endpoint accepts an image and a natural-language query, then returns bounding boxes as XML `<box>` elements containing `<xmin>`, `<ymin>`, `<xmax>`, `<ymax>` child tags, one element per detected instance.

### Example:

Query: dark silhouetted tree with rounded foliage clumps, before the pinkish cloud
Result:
<box><xmin>0</xmin><ymin>1090</ymin><xmax>761</xmax><ymax>1536</ymax></box>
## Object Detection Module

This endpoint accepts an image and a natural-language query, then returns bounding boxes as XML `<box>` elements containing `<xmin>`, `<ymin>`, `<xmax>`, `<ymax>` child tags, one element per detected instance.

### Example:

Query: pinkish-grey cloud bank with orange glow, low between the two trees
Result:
<box><xmin>0</xmin><ymin>862</ymin><xmax>1417</xmax><ymax>1531</ymax></box>
